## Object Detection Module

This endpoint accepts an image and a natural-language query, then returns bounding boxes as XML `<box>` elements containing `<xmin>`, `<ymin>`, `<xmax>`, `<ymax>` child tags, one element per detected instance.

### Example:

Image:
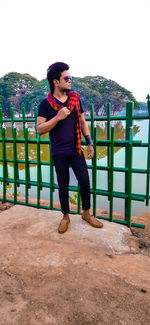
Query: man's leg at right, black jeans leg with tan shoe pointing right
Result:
<box><xmin>71</xmin><ymin>153</ymin><xmax>103</xmax><ymax>228</ymax></box>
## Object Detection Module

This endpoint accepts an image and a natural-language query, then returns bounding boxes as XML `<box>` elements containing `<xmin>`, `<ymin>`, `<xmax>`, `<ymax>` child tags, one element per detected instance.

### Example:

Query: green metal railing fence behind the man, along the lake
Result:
<box><xmin>0</xmin><ymin>95</ymin><xmax>150</xmax><ymax>228</ymax></box>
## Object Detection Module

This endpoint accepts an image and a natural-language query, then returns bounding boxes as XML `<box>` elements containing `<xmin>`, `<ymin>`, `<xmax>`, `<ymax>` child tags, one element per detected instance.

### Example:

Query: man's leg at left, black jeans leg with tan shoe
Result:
<box><xmin>53</xmin><ymin>154</ymin><xmax>70</xmax><ymax>233</ymax></box>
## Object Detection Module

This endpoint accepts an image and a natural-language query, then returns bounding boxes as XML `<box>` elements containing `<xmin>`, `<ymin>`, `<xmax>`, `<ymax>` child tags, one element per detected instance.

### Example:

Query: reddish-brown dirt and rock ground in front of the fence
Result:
<box><xmin>0</xmin><ymin>203</ymin><xmax>150</xmax><ymax>325</ymax></box>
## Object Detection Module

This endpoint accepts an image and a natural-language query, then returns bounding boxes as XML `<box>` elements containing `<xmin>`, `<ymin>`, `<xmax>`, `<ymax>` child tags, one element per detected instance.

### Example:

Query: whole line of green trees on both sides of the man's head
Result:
<box><xmin>0</xmin><ymin>72</ymin><xmax>139</xmax><ymax>116</ymax></box>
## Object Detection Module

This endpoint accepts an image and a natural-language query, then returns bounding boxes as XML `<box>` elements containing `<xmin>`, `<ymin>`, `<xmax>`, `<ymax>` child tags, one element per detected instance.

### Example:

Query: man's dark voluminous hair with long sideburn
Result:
<box><xmin>47</xmin><ymin>62</ymin><xmax>69</xmax><ymax>94</ymax></box>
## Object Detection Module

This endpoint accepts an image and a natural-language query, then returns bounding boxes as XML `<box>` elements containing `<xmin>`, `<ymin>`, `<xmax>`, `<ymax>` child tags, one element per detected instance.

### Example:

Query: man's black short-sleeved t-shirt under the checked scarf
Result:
<box><xmin>38</xmin><ymin>98</ymin><xmax>84</xmax><ymax>156</ymax></box>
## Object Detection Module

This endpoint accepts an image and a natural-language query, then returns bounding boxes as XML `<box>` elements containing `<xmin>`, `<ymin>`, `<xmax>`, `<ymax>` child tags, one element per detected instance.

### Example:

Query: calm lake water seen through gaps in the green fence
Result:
<box><xmin>0</xmin><ymin>120</ymin><xmax>150</xmax><ymax>216</ymax></box>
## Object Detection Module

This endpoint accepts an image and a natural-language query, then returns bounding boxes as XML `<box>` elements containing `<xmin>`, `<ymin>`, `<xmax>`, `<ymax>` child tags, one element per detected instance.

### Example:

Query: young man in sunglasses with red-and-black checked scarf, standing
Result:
<box><xmin>37</xmin><ymin>62</ymin><xmax>103</xmax><ymax>233</ymax></box>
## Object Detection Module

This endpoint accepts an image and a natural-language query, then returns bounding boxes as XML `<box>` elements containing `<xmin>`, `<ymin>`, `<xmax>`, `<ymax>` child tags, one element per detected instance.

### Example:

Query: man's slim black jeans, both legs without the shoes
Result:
<box><xmin>53</xmin><ymin>153</ymin><xmax>90</xmax><ymax>214</ymax></box>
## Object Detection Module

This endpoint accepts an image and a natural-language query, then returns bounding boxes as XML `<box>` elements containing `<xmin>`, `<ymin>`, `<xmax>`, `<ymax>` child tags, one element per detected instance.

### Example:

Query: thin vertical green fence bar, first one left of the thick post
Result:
<box><xmin>109</xmin><ymin>127</ymin><xmax>114</xmax><ymax>221</ymax></box>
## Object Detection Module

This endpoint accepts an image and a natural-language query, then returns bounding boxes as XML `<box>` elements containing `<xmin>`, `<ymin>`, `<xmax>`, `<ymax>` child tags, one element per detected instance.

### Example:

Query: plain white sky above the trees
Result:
<box><xmin>0</xmin><ymin>0</ymin><xmax>150</xmax><ymax>101</ymax></box>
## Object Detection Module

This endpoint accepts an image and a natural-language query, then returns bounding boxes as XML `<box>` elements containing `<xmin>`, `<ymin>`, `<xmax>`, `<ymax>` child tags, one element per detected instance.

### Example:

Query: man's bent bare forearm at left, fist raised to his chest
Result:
<box><xmin>37</xmin><ymin>107</ymin><xmax>70</xmax><ymax>134</ymax></box>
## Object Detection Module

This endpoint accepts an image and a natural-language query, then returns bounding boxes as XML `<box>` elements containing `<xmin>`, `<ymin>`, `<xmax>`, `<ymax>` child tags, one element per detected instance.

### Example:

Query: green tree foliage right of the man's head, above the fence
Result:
<box><xmin>72</xmin><ymin>76</ymin><xmax>139</xmax><ymax>115</ymax></box>
